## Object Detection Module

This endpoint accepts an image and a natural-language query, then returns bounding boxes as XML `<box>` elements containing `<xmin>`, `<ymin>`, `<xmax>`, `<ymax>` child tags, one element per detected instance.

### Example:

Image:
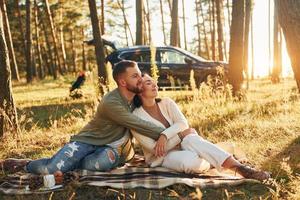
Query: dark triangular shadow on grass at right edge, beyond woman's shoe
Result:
<box><xmin>263</xmin><ymin>137</ymin><xmax>300</xmax><ymax>179</ymax></box>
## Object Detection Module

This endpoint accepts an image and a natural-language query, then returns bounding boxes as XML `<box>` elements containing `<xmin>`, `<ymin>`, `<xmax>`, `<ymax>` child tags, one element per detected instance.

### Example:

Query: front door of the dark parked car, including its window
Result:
<box><xmin>157</xmin><ymin>49</ymin><xmax>191</xmax><ymax>86</ymax></box>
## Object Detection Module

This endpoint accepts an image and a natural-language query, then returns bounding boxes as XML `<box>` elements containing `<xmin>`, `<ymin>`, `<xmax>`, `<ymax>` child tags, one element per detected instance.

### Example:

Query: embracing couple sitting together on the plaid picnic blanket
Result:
<box><xmin>0</xmin><ymin>61</ymin><xmax>270</xmax><ymax>185</ymax></box>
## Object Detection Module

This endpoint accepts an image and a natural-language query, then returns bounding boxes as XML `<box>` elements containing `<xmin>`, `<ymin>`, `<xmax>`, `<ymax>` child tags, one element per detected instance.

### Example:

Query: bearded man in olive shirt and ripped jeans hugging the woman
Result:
<box><xmin>0</xmin><ymin>61</ymin><xmax>169</xmax><ymax>174</ymax></box>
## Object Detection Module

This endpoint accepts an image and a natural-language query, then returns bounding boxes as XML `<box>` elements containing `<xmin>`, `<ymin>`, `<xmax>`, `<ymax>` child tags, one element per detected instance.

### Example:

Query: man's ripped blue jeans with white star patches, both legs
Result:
<box><xmin>26</xmin><ymin>142</ymin><xmax>120</xmax><ymax>174</ymax></box>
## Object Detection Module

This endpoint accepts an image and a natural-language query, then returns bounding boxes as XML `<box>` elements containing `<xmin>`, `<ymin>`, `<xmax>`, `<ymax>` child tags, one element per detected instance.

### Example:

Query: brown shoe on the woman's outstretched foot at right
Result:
<box><xmin>236</xmin><ymin>165</ymin><xmax>271</xmax><ymax>181</ymax></box>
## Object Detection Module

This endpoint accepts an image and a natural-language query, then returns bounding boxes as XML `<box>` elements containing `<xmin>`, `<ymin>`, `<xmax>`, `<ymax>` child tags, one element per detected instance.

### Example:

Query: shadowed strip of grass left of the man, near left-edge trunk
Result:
<box><xmin>18</xmin><ymin>102</ymin><xmax>93</xmax><ymax>129</ymax></box>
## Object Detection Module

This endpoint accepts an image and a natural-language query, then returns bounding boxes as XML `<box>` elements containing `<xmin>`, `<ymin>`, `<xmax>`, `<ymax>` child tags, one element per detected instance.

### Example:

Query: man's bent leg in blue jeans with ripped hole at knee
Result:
<box><xmin>79</xmin><ymin>146</ymin><xmax>120</xmax><ymax>171</ymax></box>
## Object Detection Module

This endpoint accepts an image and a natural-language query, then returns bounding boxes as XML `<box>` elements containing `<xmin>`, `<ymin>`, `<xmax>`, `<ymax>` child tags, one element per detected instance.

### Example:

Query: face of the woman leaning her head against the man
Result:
<box><xmin>141</xmin><ymin>74</ymin><xmax>158</xmax><ymax>98</ymax></box>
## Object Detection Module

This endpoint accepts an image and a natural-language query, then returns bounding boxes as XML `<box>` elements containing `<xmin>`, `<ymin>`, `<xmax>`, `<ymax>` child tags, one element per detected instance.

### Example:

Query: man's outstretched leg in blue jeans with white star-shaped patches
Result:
<box><xmin>26</xmin><ymin>142</ymin><xmax>96</xmax><ymax>174</ymax></box>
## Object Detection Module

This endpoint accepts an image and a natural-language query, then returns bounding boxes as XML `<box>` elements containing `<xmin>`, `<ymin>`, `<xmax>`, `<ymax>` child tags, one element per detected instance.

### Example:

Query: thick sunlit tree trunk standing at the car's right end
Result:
<box><xmin>229</xmin><ymin>0</ymin><xmax>245</xmax><ymax>95</ymax></box>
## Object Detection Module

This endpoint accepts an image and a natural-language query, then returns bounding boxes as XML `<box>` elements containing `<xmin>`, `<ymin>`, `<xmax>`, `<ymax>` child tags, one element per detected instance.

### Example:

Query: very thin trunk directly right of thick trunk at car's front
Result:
<box><xmin>243</xmin><ymin>0</ymin><xmax>252</xmax><ymax>89</ymax></box>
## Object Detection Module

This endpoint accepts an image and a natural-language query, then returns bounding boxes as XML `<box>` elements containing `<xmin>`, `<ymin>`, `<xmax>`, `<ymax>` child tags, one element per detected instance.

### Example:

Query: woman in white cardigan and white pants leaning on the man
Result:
<box><xmin>132</xmin><ymin>74</ymin><xmax>270</xmax><ymax>181</ymax></box>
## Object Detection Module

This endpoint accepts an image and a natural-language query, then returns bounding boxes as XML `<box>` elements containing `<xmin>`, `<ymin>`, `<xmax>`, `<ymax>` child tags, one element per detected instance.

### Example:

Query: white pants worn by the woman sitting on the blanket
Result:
<box><xmin>162</xmin><ymin>134</ymin><xmax>231</xmax><ymax>173</ymax></box>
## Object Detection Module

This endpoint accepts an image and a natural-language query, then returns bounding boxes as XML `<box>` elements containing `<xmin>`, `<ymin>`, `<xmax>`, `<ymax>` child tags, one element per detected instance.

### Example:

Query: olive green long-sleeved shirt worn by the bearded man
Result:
<box><xmin>71</xmin><ymin>89</ymin><xmax>164</xmax><ymax>145</ymax></box>
